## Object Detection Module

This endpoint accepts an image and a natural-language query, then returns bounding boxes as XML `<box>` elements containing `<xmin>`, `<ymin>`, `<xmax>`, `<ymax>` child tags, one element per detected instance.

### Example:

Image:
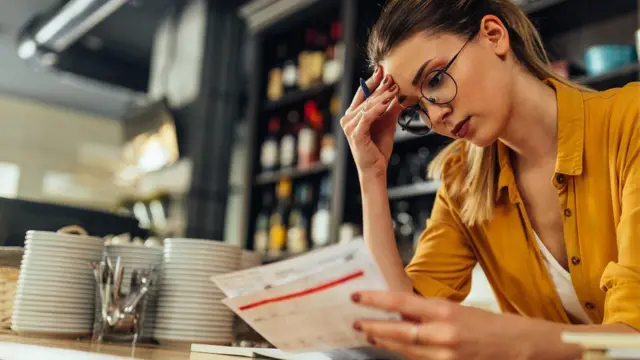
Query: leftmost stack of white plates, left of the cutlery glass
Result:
<box><xmin>11</xmin><ymin>231</ymin><xmax>104</xmax><ymax>336</ymax></box>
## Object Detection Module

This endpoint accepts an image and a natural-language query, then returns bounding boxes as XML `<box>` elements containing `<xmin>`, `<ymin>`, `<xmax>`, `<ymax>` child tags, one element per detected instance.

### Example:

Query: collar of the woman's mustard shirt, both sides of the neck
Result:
<box><xmin>496</xmin><ymin>79</ymin><xmax>585</xmax><ymax>202</ymax></box>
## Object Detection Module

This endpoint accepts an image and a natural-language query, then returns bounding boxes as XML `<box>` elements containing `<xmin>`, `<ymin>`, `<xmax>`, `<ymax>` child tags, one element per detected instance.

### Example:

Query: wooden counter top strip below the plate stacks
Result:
<box><xmin>0</xmin><ymin>330</ymin><xmax>247</xmax><ymax>360</ymax></box>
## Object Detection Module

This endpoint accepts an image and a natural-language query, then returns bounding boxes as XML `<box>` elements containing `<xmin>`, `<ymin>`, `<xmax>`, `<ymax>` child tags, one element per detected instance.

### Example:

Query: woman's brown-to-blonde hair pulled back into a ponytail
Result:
<box><xmin>367</xmin><ymin>0</ymin><xmax>588</xmax><ymax>226</ymax></box>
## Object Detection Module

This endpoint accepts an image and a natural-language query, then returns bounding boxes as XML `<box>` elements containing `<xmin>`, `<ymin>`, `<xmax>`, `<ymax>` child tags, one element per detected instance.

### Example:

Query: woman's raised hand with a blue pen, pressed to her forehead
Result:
<box><xmin>340</xmin><ymin>67</ymin><xmax>401</xmax><ymax>178</ymax></box>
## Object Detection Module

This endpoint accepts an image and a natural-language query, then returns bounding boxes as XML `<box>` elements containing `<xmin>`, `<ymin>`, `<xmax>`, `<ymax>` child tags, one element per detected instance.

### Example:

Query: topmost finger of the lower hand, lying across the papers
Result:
<box><xmin>352</xmin><ymin>291</ymin><xmax>454</xmax><ymax>321</ymax></box>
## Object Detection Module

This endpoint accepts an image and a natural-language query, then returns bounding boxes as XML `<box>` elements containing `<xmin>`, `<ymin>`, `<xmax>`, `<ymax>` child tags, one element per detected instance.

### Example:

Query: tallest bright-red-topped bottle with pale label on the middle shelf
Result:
<box><xmin>298</xmin><ymin>100</ymin><xmax>324</xmax><ymax>169</ymax></box>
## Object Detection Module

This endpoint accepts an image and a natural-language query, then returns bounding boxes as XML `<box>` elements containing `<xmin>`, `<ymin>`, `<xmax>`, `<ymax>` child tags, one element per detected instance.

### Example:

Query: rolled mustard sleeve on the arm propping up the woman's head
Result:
<box><xmin>405</xmin><ymin>186</ymin><xmax>476</xmax><ymax>302</ymax></box>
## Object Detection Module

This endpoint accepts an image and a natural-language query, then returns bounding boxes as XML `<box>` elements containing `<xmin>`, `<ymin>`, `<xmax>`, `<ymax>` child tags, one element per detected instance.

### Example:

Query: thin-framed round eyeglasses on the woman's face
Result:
<box><xmin>398</xmin><ymin>34</ymin><xmax>475</xmax><ymax>135</ymax></box>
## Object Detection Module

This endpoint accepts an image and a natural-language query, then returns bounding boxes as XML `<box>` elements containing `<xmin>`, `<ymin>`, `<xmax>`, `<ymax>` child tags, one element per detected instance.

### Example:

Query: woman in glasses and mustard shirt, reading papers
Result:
<box><xmin>341</xmin><ymin>0</ymin><xmax>640</xmax><ymax>359</ymax></box>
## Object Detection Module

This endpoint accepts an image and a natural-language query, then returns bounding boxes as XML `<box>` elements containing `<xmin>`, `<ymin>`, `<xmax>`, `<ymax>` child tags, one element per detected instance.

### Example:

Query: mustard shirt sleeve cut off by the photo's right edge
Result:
<box><xmin>600</xmin><ymin>86</ymin><xmax>640</xmax><ymax>331</ymax></box>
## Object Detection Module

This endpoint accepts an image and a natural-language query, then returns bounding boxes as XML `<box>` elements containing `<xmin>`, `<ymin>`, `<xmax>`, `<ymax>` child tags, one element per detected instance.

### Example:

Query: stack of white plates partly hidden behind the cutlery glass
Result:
<box><xmin>105</xmin><ymin>244</ymin><xmax>162</xmax><ymax>339</ymax></box>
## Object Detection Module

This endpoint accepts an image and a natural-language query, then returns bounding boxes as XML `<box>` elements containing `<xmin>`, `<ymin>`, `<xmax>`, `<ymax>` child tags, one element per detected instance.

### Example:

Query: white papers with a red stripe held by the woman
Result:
<box><xmin>212</xmin><ymin>241</ymin><xmax>400</xmax><ymax>359</ymax></box>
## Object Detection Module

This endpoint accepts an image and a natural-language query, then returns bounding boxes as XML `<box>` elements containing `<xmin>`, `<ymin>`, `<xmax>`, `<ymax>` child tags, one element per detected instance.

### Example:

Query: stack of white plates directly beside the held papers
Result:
<box><xmin>155</xmin><ymin>239</ymin><xmax>242</xmax><ymax>345</ymax></box>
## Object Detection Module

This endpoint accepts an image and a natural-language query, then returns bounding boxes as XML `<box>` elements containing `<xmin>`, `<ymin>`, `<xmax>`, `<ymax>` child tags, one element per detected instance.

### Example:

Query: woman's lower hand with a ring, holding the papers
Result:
<box><xmin>353</xmin><ymin>291</ymin><xmax>533</xmax><ymax>360</ymax></box>
